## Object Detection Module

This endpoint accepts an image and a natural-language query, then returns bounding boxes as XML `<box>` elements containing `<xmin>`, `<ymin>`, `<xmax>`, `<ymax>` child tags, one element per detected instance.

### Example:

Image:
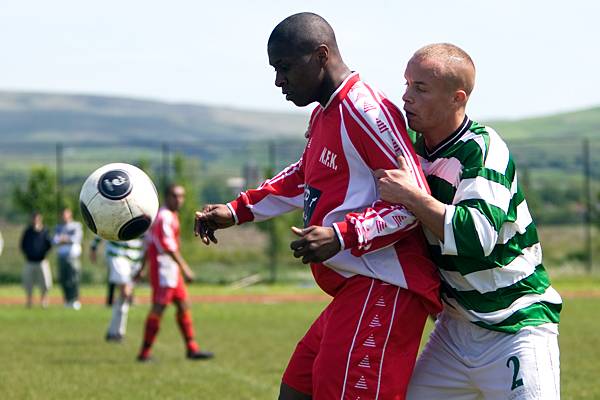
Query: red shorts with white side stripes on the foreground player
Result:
<box><xmin>282</xmin><ymin>275</ymin><xmax>428</xmax><ymax>400</ymax></box>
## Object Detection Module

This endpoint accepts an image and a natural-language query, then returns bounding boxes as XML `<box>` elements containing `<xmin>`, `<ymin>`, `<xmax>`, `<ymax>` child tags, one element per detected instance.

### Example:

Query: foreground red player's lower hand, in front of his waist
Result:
<box><xmin>290</xmin><ymin>225</ymin><xmax>341</xmax><ymax>264</ymax></box>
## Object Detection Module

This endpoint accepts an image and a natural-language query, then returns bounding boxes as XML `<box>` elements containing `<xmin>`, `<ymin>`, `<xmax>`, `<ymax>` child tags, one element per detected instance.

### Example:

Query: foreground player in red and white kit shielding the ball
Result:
<box><xmin>196</xmin><ymin>13</ymin><xmax>441</xmax><ymax>400</ymax></box>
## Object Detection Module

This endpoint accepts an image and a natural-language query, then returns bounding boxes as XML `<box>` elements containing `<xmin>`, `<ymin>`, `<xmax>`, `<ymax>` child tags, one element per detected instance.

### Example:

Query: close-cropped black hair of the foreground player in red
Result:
<box><xmin>268</xmin><ymin>12</ymin><xmax>339</xmax><ymax>55</ymax></box>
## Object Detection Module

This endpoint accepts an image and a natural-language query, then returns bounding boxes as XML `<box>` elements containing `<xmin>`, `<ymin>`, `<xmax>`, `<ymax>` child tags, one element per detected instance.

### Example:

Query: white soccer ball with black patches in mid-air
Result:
<box><xmin>79</xmin><ymin>163</ymin><xmax>158</xmax><ymax>241</ymax></box>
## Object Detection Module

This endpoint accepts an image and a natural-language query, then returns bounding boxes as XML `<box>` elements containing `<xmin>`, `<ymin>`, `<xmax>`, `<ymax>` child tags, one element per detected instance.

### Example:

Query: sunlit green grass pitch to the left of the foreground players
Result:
<box><xmin>0</xmin><ymin>288</ymin><xmax>323</xmax><ymax>399</ymax></box>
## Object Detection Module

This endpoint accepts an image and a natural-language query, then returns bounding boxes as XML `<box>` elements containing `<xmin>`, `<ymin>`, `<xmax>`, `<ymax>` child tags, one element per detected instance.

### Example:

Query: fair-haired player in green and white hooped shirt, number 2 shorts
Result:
<box><xmin>376</xmin><ymin>44</ymin><xmax>562</xmax><ymax>400</ymax></box>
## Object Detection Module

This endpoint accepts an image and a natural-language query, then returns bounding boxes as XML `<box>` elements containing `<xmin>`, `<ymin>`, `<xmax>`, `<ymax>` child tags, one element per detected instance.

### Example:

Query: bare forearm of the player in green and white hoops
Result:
<box><xmin>404</xmin><ymin>188</ymin><xmax>446</xmax><ymax>241</ymax></box>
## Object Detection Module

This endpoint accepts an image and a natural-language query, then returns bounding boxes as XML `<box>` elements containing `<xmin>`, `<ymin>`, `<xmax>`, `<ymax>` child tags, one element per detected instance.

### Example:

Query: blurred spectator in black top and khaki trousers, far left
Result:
<box><xmin>21</xmin><ymin>212</ymin><xmax>52</xmax><ymax>308</ymax></box>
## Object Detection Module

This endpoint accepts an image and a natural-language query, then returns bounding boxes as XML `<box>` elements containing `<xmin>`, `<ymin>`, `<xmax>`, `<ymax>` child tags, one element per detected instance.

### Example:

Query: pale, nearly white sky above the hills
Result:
<box><xmin>0</xmin><ymin>0</ymin><xmax>600</xmax><ymax>120</ymax></box>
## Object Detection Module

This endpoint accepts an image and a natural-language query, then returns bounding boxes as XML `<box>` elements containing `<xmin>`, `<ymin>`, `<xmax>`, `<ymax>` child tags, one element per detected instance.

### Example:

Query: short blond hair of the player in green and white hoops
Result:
<box><xmin>413</xmin><ymin>43</ymin><xmax>475</xmax><ymax>96</ymax></box>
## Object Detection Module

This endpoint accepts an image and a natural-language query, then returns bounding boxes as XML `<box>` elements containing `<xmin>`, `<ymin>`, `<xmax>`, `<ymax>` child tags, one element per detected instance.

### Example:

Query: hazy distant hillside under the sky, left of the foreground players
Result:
<box><xmin>0</xmin><ymin>92</ymin><xmax>307</xmax><ymax>144</ymax></box>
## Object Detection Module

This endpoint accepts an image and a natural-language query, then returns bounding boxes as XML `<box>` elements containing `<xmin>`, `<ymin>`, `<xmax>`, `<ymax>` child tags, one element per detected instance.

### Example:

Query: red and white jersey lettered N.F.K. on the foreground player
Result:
<box><xmin>228</xmin><ymin>73</ymin><xmax>440</xmax><ymax>311</ymax></box>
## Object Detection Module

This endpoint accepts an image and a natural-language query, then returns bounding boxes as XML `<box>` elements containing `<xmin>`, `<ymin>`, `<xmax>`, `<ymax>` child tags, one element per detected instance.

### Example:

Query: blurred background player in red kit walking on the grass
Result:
<box><xmin>138</xmin><ymin>184</ymin><xmax>213</xmax><ymax>361</ymax></box>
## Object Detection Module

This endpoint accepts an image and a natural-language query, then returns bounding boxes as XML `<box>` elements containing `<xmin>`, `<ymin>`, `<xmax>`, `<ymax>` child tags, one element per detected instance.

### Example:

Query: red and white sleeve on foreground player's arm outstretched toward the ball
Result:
<box><xmin>227</xmin><ymin>158</ymin><xmax>304</xmax><ymax>224</ymax></box>
